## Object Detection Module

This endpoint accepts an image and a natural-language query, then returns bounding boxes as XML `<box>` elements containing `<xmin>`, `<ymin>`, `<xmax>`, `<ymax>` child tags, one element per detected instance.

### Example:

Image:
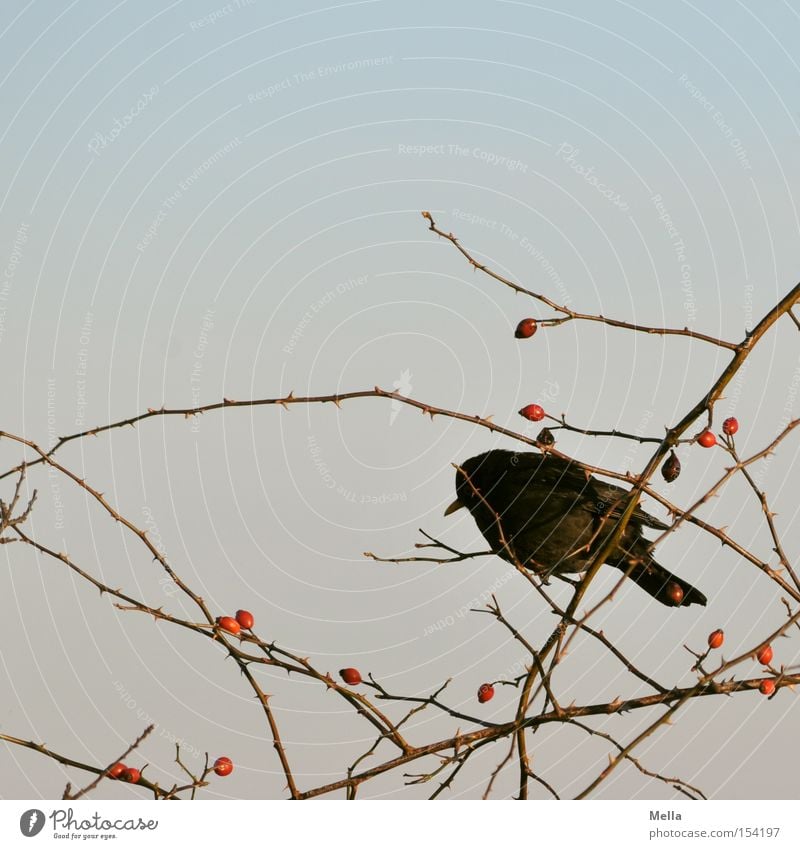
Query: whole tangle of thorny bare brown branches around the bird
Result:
<box><xmin>0</xmin><ymin>212</ymin><xmax>800</xmax><ymax>799</ymax></box>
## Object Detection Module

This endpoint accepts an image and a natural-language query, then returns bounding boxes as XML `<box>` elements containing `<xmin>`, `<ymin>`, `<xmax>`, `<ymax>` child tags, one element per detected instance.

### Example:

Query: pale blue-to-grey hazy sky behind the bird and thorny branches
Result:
<box><xmin>0</xmin><ymin>0</ymin><xmax>800</xmax><ymax>799</ymax></box>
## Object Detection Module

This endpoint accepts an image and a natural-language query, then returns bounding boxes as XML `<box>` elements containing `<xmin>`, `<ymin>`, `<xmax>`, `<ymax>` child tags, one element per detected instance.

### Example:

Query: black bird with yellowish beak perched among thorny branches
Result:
<box><xmin>445</xmin><ymin>450</ymin><xmax>706</xmax><ymax>607</ymax></box>
